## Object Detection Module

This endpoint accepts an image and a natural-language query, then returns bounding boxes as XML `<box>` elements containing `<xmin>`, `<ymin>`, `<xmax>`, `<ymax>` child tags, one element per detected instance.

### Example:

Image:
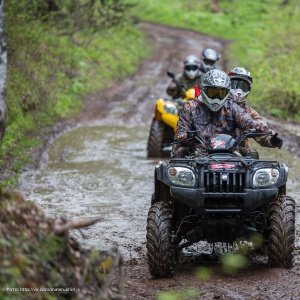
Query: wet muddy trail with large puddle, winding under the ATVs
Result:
<box><xmin>19</xmin><ymin>23</ymin><xmax>300</xmax><ymax>300</ymax></box>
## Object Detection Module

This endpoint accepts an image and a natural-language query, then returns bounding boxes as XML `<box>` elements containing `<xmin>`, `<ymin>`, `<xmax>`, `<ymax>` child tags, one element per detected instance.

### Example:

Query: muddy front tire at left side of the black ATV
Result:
<box><xmin>146</xmin><ymin>202</ymin><xmax>177</xmax><ymax>278</ymax></box>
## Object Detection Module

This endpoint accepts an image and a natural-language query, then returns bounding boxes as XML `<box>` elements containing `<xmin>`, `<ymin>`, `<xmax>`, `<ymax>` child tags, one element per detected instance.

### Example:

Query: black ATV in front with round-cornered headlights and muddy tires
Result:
<box><xmin>146</xmin><ymin>130</ymin><xmax>295</xmax><ymax>278</ymax></box>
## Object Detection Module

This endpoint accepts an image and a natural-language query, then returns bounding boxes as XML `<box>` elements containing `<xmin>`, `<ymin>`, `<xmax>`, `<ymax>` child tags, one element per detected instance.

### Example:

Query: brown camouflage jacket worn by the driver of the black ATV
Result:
<box><xmin>171</xmin><ymin>95</ymin><xmax>267</xmax><ymax>156</ymax></box>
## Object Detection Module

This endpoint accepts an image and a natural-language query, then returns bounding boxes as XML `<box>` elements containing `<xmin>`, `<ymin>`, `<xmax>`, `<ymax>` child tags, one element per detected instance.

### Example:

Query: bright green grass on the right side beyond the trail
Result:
<box><xmin>128</xmin><ymin>0</ymin><xmax>300</xmax><ymax>121</ymax></box>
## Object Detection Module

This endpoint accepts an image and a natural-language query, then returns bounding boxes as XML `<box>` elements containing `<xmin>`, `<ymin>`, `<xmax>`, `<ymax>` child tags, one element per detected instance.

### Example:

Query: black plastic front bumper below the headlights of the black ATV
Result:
<box><xmin>170</xmin><ymin>186</ymin><xmax>278</xmax><ymax>215</ymax></box>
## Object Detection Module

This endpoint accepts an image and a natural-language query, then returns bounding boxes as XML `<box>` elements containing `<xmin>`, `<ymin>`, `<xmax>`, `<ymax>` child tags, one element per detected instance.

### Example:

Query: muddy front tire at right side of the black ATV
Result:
<box><xmin>268</xmin><ymin>195</ymin><xmax>295</xmax><ymax>269</ymax></box>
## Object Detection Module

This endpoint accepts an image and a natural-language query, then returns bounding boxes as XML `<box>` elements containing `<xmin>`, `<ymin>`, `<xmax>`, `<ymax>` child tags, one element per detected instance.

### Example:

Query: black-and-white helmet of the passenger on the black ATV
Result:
<box><xmin>227</xmin><ymin>68</ymin><xmax>253</xmax><ymax>105</ymax></box>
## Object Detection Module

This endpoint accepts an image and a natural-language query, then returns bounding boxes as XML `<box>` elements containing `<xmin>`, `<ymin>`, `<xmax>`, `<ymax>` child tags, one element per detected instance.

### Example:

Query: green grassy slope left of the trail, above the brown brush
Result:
<box><xmin>0</xmin><ymin>0</ymin><xmax>151</xmax><ymax>187</ymax></box>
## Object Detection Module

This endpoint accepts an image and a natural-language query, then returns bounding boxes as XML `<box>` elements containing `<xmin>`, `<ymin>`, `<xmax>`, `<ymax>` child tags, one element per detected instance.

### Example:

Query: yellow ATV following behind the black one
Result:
<box><xmin>147</xmin><ymin>71</ymin><xmax>195</xmax><ymax>157</ymax></box>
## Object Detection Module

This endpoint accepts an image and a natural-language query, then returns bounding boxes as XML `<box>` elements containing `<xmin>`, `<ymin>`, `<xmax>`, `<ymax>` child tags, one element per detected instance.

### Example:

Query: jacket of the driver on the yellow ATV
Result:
<box><xmin>167</xmin><ymin>72</ymin><xmax>204</xmax><ymax>98</ymax></box>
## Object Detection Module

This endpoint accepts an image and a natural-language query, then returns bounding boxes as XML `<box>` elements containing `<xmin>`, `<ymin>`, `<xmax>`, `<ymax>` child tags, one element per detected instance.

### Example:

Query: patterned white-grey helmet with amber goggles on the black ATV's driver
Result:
<box><xmin>198</xmin><ymin>69</ymin><xmax>230</xmax><ymax>112</ymax></box>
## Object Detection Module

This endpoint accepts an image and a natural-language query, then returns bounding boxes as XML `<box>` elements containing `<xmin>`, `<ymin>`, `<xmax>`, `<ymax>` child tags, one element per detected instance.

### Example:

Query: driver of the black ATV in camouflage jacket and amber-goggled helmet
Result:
<box><xmin>171</xmin><ymin>69</ymin><xmax>280</xmax><ymax>157</ymax></box>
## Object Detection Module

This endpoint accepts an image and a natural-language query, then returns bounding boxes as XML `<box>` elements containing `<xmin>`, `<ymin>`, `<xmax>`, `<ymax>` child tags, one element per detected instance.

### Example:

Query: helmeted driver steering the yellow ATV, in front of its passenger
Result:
<box><xmin>167</xmin><ymin>55</ymin><xmax>204</xmax><ymax>99</ymax></box>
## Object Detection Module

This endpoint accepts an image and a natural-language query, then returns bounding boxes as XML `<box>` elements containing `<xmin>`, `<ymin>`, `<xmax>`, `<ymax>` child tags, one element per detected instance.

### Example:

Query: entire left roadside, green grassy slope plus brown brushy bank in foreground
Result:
<box><xmin>0</xmin><ymin>4</ymin><xmax>140</xmax><ymax>299</ymax></box>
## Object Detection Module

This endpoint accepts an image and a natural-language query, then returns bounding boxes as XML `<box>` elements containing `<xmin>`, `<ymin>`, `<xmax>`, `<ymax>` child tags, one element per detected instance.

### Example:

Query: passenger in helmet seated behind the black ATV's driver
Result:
<box><xmin>227</xmin><ymin>68</ymin><xmax>283</xmax><ymax>159</ymax></box>
